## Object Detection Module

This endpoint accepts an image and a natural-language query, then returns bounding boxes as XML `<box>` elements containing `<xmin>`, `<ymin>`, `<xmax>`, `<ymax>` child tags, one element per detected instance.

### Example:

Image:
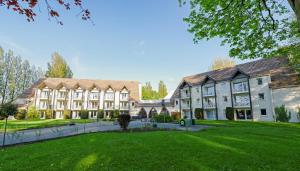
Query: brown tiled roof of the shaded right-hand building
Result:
<box><xmin>172</xmin><ymin>57</ymin><xmax>300</xmax><ymax>98</ymax></box>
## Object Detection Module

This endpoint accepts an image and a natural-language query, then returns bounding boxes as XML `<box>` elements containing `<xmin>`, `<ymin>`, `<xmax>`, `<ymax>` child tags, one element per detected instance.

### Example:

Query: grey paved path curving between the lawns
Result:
<box><xmin>0</xmin><ymin>121</ymin><xmax>208</xmax><ymax>146</ymax></box>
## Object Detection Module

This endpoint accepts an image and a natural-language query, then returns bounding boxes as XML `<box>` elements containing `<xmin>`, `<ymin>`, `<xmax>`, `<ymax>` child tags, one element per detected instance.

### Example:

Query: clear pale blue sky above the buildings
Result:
<box><xmin>0</xmin><ymin>0</ymin><xmax>248</xmax><ymax>90</ymax></box>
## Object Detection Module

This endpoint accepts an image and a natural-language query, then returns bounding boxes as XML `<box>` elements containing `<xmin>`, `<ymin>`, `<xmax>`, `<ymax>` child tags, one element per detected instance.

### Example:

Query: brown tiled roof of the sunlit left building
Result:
<box><xmin>22</xmin><ymin>78</ymin><xmax>139</xmax><ymax>101</ymax></box>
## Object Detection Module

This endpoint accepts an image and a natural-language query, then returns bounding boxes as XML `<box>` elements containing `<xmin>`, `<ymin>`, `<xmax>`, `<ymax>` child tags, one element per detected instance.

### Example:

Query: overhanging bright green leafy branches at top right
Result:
<box><xmin>179</xmin><ymin>0</ymin><xmax>300</xmax><ymax>59</ymax></box>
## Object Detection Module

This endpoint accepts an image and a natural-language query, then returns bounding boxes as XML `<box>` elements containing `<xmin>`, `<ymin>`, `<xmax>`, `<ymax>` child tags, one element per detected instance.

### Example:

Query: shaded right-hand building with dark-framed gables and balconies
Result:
<box><xmin>173</xmin><ymin>57</ymin><xmax>300</xmax><ymax>122</ymax></box>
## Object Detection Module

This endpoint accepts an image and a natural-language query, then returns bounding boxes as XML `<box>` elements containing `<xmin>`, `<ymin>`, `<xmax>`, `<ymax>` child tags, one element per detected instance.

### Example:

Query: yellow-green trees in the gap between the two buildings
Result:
<box><xmin>142</xmin><ymin>81</ymin><xmax>168</xmax><ymax>100</ymax></box>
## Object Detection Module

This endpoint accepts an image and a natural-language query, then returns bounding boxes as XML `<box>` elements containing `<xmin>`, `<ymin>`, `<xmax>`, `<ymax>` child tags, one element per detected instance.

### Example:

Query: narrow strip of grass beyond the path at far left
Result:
<box><xmin>0</xmin><ymin>119</ymin><xmax>95</xmax><ymax>132</ymax></box>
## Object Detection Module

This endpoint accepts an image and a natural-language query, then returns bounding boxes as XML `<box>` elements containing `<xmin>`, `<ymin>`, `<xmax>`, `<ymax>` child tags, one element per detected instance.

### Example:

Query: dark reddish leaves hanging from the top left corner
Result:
<box><xmin>0</xmin><ymin>0</ymin><xmax>91</xmax><ymax>25</ymax></box>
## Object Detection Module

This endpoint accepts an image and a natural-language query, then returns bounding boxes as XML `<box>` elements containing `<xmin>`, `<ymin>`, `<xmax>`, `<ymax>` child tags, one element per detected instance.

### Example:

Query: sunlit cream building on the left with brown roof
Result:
<box><xmin>17</xmin><ymin>78</ymin><xmax>141</xmax><ymax>119</ymax></box>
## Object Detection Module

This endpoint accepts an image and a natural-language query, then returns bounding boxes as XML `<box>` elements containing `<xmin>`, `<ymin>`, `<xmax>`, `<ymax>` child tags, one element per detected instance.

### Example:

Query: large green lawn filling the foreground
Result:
<box><xmin>0</xmin><ymin>121</ymin><xmax>300</xmax><ymax>171</ymax></box>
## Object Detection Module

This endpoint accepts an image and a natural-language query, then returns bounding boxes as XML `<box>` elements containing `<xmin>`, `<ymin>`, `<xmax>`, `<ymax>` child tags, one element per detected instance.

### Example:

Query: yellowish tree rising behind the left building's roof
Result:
<box><xmin>46</xmin><ymin>52</ymin><xmax>73</xmax><ymax>78</ymax></box>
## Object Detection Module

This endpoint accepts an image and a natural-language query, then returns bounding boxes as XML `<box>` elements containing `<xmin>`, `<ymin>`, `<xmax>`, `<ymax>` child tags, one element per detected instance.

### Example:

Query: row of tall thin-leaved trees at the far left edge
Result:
<box><xmin>0</xmin><ymin>47</ymin><xmax>43</xmax><ymax>104</ymax></box>
